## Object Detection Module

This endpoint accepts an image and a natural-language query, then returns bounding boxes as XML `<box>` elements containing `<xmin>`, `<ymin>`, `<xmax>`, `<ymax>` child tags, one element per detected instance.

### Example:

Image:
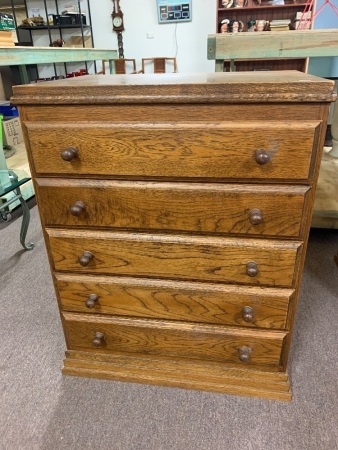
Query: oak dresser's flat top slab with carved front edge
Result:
<box><xmin>12</xmin><ymin>71</ymin><xmax>336</xmax><ymax>105</ymax></box>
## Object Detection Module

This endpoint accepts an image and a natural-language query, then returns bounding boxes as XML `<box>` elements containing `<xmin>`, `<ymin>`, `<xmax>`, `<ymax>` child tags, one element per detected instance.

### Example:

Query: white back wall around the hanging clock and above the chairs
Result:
<box><xmin>90</xmin><ymin>0</ymin><xmax>216</xmax><ymax>73</ymax></box>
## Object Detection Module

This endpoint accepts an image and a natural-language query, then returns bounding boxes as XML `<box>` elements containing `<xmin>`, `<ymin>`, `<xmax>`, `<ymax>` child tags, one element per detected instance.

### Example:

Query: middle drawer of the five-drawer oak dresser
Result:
<box><xmin>47</xmin><ymin>228</ymin><xmax>302</xmax><ymax>287</ymax></box>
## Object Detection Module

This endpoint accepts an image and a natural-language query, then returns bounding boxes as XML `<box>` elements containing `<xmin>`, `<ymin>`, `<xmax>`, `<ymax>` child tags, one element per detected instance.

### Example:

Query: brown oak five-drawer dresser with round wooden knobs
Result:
<box><xmin>12</xmin><ymin>72</ymin><xmax>334</xmax><ymax>400</ymax></box>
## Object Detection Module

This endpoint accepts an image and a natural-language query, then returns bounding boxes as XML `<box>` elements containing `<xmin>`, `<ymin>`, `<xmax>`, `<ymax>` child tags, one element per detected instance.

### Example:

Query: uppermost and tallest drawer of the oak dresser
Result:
<box><xmin>26</xmin><ymin>121</ymin><xmax>320</xmax><ymax>180</ymax></box>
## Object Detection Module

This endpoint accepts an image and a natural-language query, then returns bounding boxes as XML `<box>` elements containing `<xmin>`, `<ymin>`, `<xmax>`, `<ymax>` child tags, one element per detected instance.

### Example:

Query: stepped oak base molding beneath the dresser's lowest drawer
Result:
<box><xmin>62</xmin><ymin>351</ymin><xmax>292</xmax><ymax>401</ymax></box>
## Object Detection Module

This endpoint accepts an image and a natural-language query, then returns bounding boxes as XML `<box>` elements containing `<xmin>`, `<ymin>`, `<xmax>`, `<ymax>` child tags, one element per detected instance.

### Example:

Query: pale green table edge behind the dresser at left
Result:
<box><xmin>0</xmin><ymin>46</ymin><xmax>118</xmax><ymax>66</ymax></box>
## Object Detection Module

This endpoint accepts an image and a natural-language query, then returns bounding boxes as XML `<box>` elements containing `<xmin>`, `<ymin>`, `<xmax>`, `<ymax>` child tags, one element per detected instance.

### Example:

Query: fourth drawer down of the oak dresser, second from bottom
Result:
<box><xmin>55</xmin><ymin>273</ymin><xmax>293</xmax><ymax>329</ymax></box>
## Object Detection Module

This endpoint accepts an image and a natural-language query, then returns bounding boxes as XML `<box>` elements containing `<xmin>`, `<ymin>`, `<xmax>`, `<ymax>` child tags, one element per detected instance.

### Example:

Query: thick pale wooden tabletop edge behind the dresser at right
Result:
<box><xmin>208</xmin><ymin>29</ymin><xmax>338</xmax><ymax>60</ymax></box>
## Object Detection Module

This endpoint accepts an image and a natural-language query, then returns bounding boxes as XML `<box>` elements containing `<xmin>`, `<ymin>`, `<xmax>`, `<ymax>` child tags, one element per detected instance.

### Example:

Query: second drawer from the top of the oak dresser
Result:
<box><xmin>37</xmin><ymin>178</ymin><xmax>309</xmax><ymax>237</ymax></box>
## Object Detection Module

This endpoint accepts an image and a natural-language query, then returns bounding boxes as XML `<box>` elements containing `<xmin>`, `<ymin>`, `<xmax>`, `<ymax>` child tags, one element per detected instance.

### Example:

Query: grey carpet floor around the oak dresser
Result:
<box><xmin>0</xmin><ymin>207</ymin><xmax>338</xmax><ymax>450</ymax></box>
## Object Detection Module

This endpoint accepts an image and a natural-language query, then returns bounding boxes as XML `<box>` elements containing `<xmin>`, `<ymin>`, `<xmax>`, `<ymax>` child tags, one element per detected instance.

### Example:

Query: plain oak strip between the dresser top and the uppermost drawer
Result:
<box><xmin>19</xmin><ymin>102</ymin><xmax>322</xmax><ymax>124</ymax></box>
